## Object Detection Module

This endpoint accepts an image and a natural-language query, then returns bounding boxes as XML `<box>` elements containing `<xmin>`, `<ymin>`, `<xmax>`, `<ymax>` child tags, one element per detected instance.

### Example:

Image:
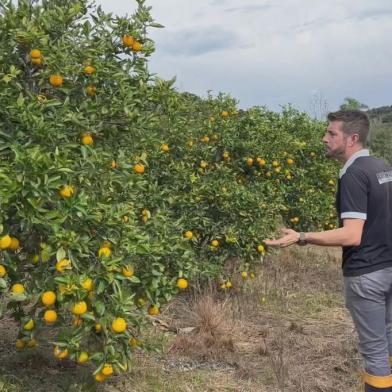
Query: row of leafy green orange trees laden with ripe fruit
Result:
<box><xmin>0</xmin><ymin>0</ymin><xmax>336</xmax><ymax>381</ymax></box>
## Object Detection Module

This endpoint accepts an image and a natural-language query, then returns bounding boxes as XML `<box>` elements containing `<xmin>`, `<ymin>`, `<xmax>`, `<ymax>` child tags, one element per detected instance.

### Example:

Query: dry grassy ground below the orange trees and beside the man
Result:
<box><xmin>0</xmin><ymin>247</ymin><xmax>361</xmax><ymax>392</ymax></box>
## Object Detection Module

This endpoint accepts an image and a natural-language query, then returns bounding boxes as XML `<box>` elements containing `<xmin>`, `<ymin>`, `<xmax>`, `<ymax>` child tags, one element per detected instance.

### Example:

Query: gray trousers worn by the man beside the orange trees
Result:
<box><xmin>344</xmin><ymin>267</ymin><xmax>392</xmax><ymax>376</ymax></box>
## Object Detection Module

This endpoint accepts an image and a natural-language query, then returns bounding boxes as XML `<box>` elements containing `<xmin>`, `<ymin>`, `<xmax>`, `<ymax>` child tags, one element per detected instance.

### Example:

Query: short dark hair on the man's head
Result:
<box><xmin>327</xmin><ymin>110</ymin><xmax>370</xmax><ymax>145</ymax></box>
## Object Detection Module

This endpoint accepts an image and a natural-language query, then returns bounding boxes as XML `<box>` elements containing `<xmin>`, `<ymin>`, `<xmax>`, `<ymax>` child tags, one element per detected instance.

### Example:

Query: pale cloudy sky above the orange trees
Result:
<box><xmin>96</xmin><ymin>0</ymin><xmax>392</xmax><ymax>114</ymax></box>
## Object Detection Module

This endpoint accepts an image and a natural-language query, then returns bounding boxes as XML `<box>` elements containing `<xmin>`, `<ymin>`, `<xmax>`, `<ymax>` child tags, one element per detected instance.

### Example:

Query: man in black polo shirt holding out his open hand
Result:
<box><xmin>265</xmin><ymin>110</ymin><xmax>392</xmax><ymax>392</ymax></box>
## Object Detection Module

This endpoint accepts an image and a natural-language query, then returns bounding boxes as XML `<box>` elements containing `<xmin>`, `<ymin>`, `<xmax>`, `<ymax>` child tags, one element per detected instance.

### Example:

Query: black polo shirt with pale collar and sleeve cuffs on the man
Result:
<box><xmin>336</xmin><ymin>150</ymin><xmax>392</xmax><ymax>276</ymax></box>
